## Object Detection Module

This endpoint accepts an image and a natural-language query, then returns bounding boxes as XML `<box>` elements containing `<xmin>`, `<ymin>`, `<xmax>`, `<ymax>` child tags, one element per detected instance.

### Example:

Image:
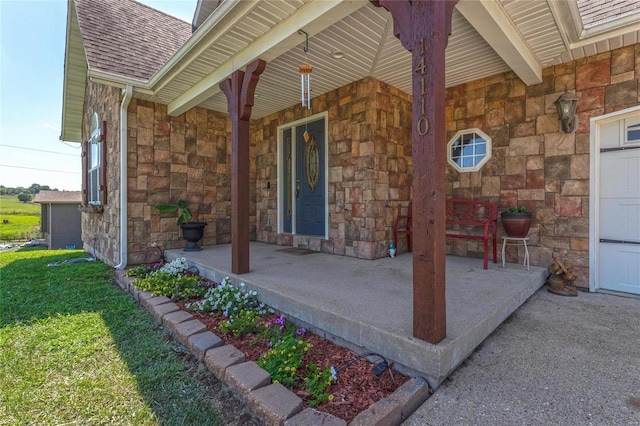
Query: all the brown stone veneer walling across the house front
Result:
<box><xmin>83</xmin><ymin>45</ymin><xmax>640</xmax><ymax>276</ymax></box>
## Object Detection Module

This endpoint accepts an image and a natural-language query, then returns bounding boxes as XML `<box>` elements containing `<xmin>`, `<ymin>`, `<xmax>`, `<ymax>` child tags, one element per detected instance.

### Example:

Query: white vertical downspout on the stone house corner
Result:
<box><xmin>115</xmin><ymin>84</ymin><xmax>133</xmax><ymax>269</ymax></box>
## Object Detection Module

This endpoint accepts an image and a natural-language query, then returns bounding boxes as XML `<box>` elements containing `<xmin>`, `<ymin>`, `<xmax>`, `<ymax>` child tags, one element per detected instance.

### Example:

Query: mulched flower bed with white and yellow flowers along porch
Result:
<box><xmin>128</xmin><ymin>258</ymin><xmax>408</xmax><ymax>422</ymax></box>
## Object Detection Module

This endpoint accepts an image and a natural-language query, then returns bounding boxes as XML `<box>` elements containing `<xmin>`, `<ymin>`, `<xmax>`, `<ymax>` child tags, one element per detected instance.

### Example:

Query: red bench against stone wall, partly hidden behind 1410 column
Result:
<box><xmin>393</xmin><ymin>198</ymin><xmax>498</xmax><ymax>269</ymax></box>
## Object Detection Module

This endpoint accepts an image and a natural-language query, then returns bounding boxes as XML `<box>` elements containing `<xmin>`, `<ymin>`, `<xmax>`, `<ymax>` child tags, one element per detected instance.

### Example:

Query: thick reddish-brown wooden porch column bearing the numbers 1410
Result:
<box><xmin>371</xmin><ymin>0</ymin><xmax>458</xmax><ymax>344</ymax></box>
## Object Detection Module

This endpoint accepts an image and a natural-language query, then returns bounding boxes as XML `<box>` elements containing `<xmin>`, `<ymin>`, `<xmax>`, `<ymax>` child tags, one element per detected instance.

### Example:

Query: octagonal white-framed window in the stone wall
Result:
<box><xmin>447</xmin><ymin>129</ymin><xmax>491</xmax><ymax>172</ymax></box>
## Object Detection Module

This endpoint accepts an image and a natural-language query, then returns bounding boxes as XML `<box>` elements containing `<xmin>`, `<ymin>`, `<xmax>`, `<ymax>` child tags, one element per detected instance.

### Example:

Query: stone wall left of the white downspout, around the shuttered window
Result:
<box><xmin>81</xmin><ymin>80</ymin><xmax>120</xmax><ymax>265</ymax></box>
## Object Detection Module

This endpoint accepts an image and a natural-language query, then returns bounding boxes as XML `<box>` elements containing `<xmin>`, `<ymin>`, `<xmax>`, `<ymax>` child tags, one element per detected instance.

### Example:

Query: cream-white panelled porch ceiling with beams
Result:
<box><xmin>101</xmin><ymin>0</ymin><xmax>640</xmax><ymax>118</ymax></box>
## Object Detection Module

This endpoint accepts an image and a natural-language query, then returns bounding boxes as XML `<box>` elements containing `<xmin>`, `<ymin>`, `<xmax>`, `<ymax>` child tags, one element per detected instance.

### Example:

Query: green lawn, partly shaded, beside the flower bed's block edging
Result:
<box><xmin>0</xmin><ymin>249</ymin><xmax>221</xmax><ymax>425</ymax></box>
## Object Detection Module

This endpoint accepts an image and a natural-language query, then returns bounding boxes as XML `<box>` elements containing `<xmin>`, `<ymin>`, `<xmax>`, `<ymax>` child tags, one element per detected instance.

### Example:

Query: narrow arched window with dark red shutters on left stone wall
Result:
<box><xmin>82</xmin><ymin>113</ymin><xmax>106</xmax><ymax>205</ymax></box>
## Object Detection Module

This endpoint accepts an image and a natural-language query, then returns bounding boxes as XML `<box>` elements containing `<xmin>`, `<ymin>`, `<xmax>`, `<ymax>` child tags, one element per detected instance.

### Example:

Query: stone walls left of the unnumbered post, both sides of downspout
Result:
<box><xmin>82</xmin><ymin>81</ymin><xmax>238</xmax><ymax>265</ymax></box>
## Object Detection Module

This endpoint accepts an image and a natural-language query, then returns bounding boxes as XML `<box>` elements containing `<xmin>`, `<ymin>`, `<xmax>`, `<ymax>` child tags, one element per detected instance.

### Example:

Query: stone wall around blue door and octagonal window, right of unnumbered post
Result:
<box><xmin>252</xmin><ymin>45</ymin><xmax>640</xmax><ymax>287</ymax></box>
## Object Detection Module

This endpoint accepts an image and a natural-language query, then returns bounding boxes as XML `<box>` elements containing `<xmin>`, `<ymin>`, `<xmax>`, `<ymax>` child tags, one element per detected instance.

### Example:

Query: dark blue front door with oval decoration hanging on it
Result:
<box><xmin>295</xmin><ymin>119</ymin><xmax>326</xmax><ymax>236</ymax></box>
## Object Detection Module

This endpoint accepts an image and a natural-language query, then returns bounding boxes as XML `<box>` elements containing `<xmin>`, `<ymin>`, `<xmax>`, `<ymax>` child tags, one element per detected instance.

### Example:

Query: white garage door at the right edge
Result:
<box><xmin>596</xmin><ymin>111</ymin><xmax>640</xmax><ymax>294</ymax></box>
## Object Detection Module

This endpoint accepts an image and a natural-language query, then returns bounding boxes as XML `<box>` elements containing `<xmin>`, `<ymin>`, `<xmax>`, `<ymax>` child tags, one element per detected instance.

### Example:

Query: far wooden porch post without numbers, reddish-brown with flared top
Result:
<box><xmin>220</xmin><ymin>59</ymin><xmax>266</xmax><ymax>274</ymax></box>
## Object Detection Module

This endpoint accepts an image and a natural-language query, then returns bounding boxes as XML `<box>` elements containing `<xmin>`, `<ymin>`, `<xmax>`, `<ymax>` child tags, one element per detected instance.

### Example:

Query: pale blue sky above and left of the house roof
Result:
<box><xmin>0</xmin><ymin>0</ymin><xmax>196</xmax><ymax>190</ymax></box>
